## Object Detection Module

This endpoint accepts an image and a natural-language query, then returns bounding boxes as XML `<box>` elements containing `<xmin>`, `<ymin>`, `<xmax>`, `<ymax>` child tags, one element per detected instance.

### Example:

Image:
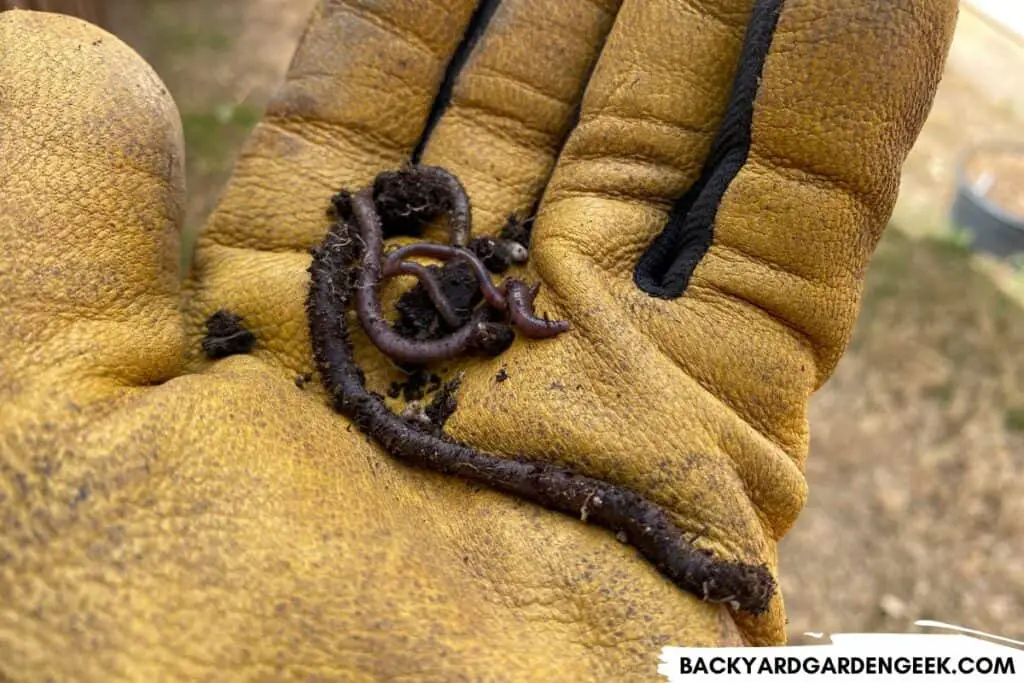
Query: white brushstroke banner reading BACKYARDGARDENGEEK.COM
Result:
<box><xmin>657</xmin><ymin>622</ymin><xmax>1024</xmax><ymax>683</ymax></box>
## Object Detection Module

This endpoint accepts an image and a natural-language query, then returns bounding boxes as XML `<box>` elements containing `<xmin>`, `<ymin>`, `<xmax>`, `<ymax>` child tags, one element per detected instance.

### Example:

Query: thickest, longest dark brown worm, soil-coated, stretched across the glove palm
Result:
<box><xmin>306</xmin><ymin>221</ymin><xmax>775</xmax><ymax>614</ymax></box>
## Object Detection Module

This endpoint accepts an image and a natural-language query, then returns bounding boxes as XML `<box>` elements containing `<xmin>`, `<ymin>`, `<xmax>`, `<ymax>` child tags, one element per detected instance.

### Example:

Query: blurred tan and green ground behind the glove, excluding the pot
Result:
<box><xmin>7</xmin><ymin>0</ymin><xmax>1024</xmax><ymax>643</ymax></box>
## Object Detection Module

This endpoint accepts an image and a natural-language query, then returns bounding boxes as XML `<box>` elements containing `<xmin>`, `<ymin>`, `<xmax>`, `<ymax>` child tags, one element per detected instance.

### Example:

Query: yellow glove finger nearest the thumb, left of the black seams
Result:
<box><xmin>198</xmin><ymin>0</ymin><xmax>476</xmax><ymax>253</ymax></box>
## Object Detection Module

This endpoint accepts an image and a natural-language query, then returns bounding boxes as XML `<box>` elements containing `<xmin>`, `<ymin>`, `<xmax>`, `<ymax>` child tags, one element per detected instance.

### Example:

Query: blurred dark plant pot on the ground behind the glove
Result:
<box><xmin>950</xmin><ymin>143</ymin><xmax>1024</xmax><ymax>258</ymax></box>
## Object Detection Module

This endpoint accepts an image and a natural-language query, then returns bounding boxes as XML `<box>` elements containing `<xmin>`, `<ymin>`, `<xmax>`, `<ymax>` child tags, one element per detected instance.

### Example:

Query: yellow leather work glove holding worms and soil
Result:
<box><xmin>0</xmin><ymin>0</ymin><xmax>956</xmax><ymax>681</ymax></box>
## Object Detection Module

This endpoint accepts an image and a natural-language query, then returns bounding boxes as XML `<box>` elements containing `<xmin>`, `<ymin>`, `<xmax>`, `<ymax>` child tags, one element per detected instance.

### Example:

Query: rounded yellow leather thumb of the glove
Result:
<box><xmin>0</xmin><ymin>10</ymin><xmax>183</xmax><ymax>395</ymax></box>
